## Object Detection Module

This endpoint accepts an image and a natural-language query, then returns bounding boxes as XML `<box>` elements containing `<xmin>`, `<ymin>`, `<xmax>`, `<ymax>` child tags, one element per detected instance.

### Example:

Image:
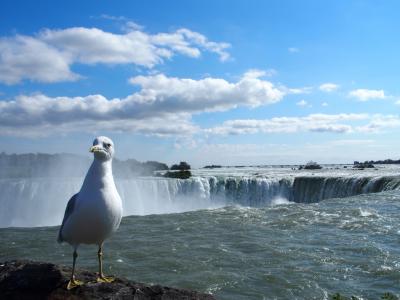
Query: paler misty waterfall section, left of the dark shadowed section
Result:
<box><xmin>0</xmin><ymin>177</ymin><xmax>291</xmax><ymax>227</ymax></box>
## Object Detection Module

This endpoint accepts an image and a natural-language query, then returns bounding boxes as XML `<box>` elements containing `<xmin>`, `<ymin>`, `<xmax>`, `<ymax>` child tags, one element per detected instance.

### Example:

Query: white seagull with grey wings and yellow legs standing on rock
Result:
<box><xmin>57</xmin><ymin>136</ymin><xmax>122</xmax><ymax>290</ymax></box>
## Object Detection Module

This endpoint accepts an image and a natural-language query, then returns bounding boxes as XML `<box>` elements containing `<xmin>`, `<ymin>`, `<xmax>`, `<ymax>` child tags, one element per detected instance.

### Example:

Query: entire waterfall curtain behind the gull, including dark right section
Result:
<box><xmin>0</xmin><ymin>176</ymin><xmax>400</xmax><ymax>227</ymax></box>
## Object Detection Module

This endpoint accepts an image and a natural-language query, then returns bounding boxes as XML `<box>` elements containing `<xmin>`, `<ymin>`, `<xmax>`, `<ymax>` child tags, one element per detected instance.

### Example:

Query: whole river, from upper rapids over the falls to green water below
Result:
<box><xmin>0</xmin><ymin>165</ymin><xmax>400</xmax><ymax>299</ymax></box>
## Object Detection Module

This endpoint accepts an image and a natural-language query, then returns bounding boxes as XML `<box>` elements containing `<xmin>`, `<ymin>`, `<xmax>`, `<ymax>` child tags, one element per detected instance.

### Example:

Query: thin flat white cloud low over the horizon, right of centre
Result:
<box><xmin>206</xmin><ymin>114</ymin><xmax>369</xmax><ymax>135</ymax></box>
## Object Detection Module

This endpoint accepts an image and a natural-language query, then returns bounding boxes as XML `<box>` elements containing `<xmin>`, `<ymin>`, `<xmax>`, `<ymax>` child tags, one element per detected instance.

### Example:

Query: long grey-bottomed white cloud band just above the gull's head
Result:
<box><xmin>0</xmin><ymin>72</ymin><xmax>284</xmax><ymax>135</ymax></box>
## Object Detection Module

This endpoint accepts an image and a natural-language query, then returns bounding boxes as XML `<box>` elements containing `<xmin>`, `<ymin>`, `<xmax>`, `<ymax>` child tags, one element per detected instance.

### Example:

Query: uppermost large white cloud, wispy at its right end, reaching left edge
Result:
<box><xmin>0</xmin><ymin>25</ymin><xmax>230</xmax><ymax>84</ymax></box>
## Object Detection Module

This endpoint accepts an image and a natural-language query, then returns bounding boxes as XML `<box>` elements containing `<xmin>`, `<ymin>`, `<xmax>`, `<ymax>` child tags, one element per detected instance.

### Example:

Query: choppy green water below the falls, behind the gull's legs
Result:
<box><xmin>0</xmin><ymin>192</ymin><xmax>400</xmax><ymax>299</ymax></box>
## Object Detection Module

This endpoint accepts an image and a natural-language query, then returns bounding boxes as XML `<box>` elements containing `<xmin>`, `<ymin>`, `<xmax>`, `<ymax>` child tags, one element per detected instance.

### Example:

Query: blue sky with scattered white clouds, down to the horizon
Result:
<box><xmin>0</xmin><ymin>0</ymin><xmax>400</xmax><ymax>166</ymax></box>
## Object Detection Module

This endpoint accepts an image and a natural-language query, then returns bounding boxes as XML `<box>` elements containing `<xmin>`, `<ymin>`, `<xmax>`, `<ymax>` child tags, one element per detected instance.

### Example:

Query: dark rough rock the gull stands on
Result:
<box><xmin>0</xmin><ymin>260</ymin><xmax>214</xmax><ymax>300</ymax></box>
